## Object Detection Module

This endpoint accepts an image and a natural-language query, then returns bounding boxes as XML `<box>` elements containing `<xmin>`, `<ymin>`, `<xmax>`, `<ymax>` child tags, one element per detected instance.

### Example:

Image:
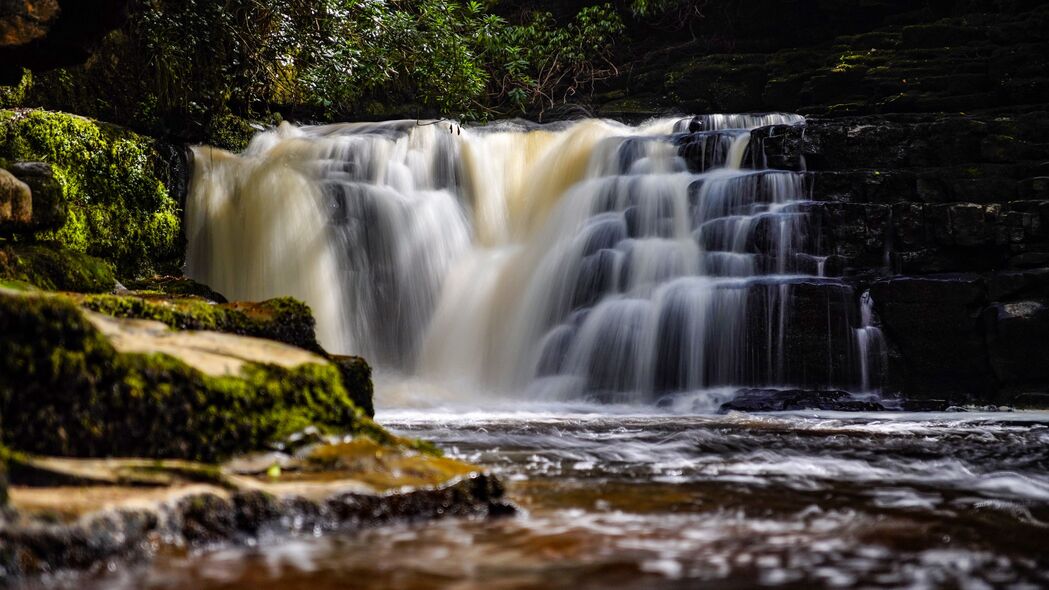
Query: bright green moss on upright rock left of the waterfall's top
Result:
<box><xmin>0</xmin><ymin>110</ymin><xmax>181</xmax><ymax>277</ymax></box>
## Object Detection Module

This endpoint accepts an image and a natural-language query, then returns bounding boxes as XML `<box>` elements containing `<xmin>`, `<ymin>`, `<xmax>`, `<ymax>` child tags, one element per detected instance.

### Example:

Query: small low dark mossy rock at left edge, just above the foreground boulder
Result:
<box><xmin>0</xmin><ymin>244</ymin><xmax>116</xmax><ymax>293</ymax></box>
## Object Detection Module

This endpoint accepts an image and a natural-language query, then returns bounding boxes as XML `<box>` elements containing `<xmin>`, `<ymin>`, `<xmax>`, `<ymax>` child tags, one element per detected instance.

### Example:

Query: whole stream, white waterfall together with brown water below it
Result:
<box><xmin>90</xmin><ymin>114</ymin><xmax>1049</xmax><ymax>590</ymax></box>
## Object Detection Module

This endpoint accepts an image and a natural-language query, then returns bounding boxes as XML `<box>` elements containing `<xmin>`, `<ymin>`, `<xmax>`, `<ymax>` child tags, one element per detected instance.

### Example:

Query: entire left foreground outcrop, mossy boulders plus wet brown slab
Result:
<box><xmin>0</xmin><ymin>278</ymin><xmax>514</xmax><ymax>583</ymax></box>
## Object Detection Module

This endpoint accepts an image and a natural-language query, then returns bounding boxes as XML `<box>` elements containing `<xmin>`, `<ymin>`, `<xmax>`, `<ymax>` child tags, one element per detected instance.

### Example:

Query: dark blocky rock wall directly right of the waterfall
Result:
<box><xmin>709</xmin><ymin>110</ymin><xmax>1049</xmax><ymax>402</ymax></box>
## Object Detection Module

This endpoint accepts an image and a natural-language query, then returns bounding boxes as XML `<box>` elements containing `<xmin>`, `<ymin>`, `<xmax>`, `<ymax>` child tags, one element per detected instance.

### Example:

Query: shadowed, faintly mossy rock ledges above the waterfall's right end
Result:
<box><xmin>591</xmin><ymin>0</ymin><xmax>1049</xmax><ymax>119</ymax></box>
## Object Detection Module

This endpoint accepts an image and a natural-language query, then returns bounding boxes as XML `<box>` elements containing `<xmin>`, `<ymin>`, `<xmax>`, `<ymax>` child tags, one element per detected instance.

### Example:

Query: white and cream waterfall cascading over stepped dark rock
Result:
<box><xmin>187</xmin><ymin>114</ymin><xmax>881</xmax><ymax>402</ymax></box>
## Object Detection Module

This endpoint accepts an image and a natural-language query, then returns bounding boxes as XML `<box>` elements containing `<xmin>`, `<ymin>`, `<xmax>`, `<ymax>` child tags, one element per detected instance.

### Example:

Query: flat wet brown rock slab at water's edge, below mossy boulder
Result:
<box><xmin>0</xmin><ymin>443</ymin><xmax>514</xmax><ymax>582</ymax></box>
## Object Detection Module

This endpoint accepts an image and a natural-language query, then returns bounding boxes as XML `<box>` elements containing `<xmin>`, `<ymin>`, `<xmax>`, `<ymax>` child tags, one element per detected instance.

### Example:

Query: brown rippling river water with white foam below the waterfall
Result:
<box><xmin>51</xmin><ymin>405</ymin><xmax>1049</xmax><ymax>590</ymax></box>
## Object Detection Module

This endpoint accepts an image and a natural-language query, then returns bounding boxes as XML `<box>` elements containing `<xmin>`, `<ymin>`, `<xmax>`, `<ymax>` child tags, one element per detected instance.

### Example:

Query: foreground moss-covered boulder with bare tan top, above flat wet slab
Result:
<box><xmin>0</xmin><ymin>290</ymin><xmax>365</xmax><ymax>460</ymax></box>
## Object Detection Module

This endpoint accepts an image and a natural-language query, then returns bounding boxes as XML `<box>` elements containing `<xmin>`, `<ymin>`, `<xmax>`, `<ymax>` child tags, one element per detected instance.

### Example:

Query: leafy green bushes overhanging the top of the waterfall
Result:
<box><xmin>2</xmin><ymin>0</ymin><xmax>625</xmax><ymax>130</ymax></box>
